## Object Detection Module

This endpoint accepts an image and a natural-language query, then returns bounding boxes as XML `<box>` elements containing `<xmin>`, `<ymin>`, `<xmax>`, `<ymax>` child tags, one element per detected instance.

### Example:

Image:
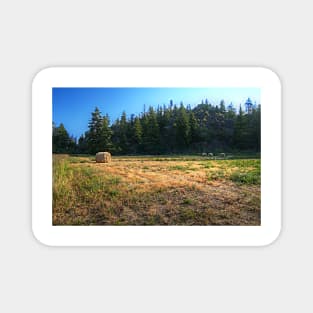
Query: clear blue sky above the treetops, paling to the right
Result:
<box><xmin>52</xmin><ymin>88</ymin><xmax>260</xmax><ymax>138</ymax></box>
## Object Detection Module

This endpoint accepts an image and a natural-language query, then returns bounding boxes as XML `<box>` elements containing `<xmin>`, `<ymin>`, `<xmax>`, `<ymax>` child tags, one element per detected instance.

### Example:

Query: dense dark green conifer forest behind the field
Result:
<box><xmin>53</xmin><ymin>99</ymin><xmax>261</xmax><ymax>155</ymax></box>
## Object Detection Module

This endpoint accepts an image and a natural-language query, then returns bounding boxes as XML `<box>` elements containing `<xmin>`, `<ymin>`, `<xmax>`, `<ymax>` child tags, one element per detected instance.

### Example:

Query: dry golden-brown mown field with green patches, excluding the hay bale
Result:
<box><xmin>53</xmin><ymin>155</ymin><xmax>261</xmax><ymax>225</ymax></box>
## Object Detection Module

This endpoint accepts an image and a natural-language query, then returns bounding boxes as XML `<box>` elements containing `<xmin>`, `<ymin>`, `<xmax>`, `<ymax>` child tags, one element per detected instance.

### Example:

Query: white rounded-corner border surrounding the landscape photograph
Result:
<box><xmin>32</xmin><ymin>67</ymin><xmax>281</xmax><ymax>246</ymax></box>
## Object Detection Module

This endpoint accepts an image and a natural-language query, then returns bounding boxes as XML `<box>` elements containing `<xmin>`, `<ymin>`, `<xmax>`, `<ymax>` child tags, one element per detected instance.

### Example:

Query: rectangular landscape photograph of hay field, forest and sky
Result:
<box><xmin>51</xmin><ymin>86</ymin><xmax>262</xmax><ymax>226</ymax></box>
